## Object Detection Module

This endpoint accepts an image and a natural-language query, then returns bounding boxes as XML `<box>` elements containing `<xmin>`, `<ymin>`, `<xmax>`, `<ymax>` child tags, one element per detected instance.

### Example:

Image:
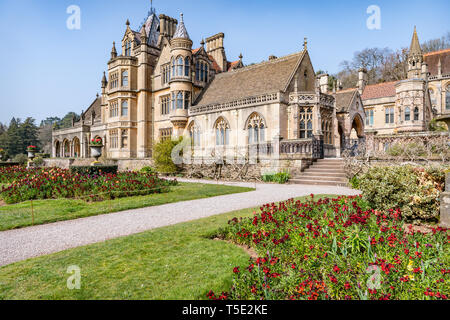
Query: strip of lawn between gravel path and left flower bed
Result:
<box><xmin>0</xmin><ymin>183</ymin><xmax>254</xmax><ymax>231</ymax></box>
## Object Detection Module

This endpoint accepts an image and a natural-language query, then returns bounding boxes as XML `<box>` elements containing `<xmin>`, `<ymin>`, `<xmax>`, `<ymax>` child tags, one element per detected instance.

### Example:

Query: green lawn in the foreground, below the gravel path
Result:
<box><xmin>0</xmin><ymin>195</ymin><xmax>334</xmax><ymax>300</ymax></box>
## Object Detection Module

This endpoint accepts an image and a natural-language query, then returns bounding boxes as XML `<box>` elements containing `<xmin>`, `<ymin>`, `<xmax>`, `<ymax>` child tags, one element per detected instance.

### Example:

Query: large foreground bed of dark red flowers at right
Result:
<box><xmin>208</xmin><ymin>197</ymin><xmax>450</xmax><ymax>300</ymax></box>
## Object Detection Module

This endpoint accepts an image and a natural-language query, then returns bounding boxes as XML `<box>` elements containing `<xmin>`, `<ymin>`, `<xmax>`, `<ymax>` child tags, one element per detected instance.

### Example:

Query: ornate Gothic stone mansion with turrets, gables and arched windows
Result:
<box><xmin>52</xmin><ymin>6</ymin><xmax>450</xmax><ymax>165</ymax></box>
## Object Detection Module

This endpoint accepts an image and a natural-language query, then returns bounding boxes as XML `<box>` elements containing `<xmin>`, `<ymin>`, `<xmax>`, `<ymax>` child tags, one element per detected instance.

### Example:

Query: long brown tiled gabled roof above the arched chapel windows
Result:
<box><xmin>196</xmin><ymin>51</ymin><xmax>305</xmax><ymax>105</ymax></box>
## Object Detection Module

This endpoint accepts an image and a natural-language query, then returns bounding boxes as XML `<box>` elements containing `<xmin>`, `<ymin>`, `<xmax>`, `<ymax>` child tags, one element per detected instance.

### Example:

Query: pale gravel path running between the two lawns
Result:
<box><xmin>0</xmin><ymin>179</ymin><xmax>358</xmax><ymax>266</ymax></box>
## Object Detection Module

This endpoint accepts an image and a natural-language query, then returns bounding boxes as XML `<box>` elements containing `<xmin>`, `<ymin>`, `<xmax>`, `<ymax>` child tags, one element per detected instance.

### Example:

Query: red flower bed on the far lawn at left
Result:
<box><xmin>0</xmin><ymin>167</ymin><xmax>176</xmax><ymax>204</ymax></box>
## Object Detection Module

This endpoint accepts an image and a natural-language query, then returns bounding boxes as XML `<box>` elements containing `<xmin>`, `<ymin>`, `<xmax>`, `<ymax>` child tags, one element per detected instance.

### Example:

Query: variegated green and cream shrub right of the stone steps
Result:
<box><xmin>357</xmin><ymin>165</ymin><xmax>445</xmax><ymax>221</ymax></box>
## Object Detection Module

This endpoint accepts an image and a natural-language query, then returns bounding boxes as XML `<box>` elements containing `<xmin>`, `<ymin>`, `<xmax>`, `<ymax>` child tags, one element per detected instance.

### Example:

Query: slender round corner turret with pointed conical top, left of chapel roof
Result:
<box><xmin>170</xmin><ymin>14</ymin><xmax>193</xmax><ymax>138</ymax></box>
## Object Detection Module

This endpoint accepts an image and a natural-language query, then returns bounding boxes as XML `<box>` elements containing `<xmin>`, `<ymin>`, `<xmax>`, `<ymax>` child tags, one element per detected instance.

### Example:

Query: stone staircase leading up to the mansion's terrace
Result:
<box><xmin>289</xmin><ymin>159</ymin><xmax>348</xmax><ymax>187</ymax></box>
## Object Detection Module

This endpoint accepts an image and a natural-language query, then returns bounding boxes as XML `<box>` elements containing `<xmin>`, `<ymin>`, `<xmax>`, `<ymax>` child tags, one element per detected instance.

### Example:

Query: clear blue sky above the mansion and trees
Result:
<box><xmin>0</xmin><ymin>0</ymin><xmax>450</xmax><ymax>123</ymax></box>
